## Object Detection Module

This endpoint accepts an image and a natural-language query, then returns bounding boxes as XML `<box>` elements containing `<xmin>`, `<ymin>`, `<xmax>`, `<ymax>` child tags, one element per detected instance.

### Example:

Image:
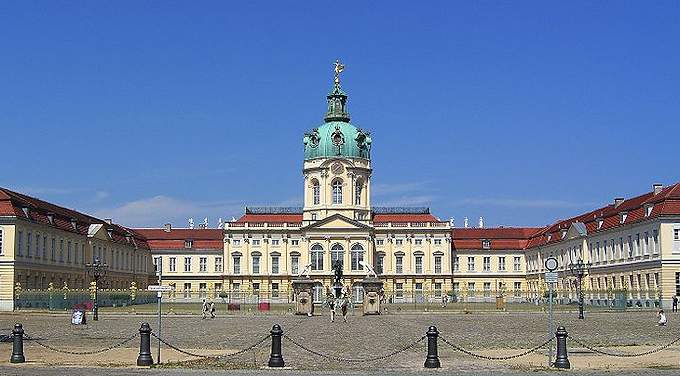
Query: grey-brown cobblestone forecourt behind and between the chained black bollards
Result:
<box><xmin>0</xmin><ymin>312</ymin><xmax>680</xmax><ymax>374</ymax></box>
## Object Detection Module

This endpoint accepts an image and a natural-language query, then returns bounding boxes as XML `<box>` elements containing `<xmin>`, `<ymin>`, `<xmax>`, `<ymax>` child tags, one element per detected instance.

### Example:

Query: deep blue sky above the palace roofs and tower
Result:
<box><xmin>0</xmin><ymin>1</ymin><xmax>680</xmax><ymax>226</ymax></box>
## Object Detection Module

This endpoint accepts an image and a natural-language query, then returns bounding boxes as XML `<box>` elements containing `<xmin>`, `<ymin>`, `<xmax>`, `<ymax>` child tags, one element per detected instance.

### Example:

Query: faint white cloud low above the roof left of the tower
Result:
<box><xmin>94</xmin><ymin>195</ymin><xmax>243</xmax><ymax>227</ymax></box>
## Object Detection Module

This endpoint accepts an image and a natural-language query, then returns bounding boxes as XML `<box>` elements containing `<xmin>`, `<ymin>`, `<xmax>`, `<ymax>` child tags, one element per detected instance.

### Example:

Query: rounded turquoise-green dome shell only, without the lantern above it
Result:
<box><xmin>303</xmin><ymin>121</ymin><xmax>371</xmax><ymax>159</ymax></box>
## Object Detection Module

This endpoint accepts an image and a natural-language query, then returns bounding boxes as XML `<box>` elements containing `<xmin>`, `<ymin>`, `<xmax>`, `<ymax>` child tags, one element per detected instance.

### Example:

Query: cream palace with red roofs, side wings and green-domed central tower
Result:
<box><xmin>0</xmin><ymin>63</ymin><xmax>680</xmax><ymax>310</ymax></box>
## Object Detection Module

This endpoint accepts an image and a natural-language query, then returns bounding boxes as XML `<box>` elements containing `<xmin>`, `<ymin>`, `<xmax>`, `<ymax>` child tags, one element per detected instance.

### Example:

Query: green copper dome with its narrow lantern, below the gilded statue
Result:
<box><xmin>302</xmin><ymin>80</ymin><xmax>371</xmax><ymax>160</ymax></box>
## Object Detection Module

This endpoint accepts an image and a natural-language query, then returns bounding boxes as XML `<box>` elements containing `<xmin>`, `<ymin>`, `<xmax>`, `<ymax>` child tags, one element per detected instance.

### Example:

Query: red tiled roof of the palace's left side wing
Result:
<box><xmin>0</xmin><ymin>187</ymin><xmax>148</xmax><ymax>249</ymax></box>
